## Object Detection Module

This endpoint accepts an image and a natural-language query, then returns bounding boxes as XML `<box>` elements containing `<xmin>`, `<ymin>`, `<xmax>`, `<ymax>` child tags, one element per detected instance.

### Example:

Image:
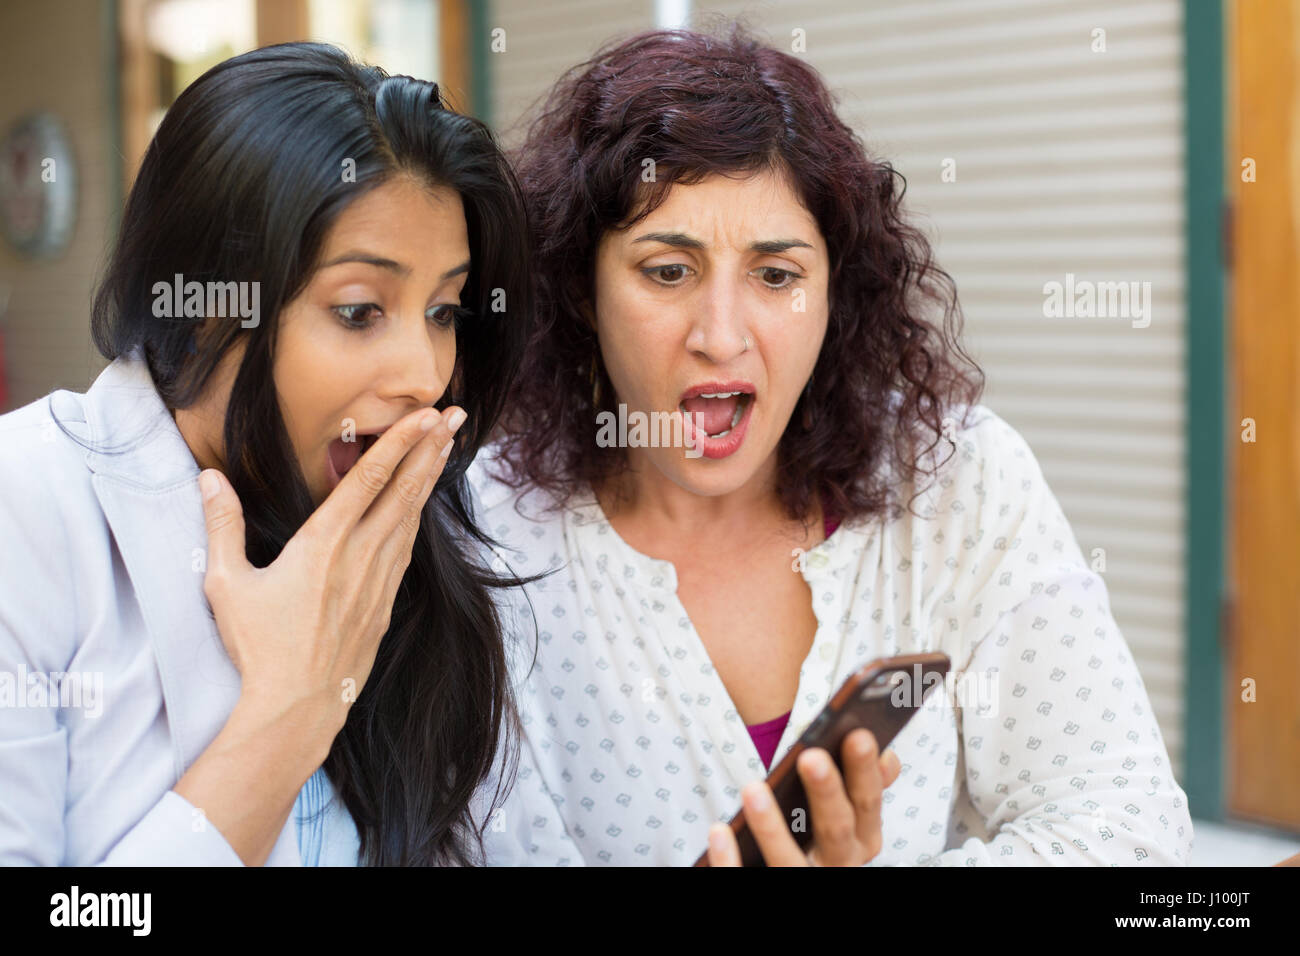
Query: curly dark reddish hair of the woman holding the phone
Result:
<box><xmin>498</xmin><ymin>23</ymin><xmax>984</xmax><ymax>520</ymax></box>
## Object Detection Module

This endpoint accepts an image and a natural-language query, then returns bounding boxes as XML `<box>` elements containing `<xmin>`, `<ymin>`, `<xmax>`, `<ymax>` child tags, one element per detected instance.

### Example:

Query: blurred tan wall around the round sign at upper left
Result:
<box><xmin>0</xmin><ymin>0</ymin><xmax>117</xmax><ymax>411</ymax></box>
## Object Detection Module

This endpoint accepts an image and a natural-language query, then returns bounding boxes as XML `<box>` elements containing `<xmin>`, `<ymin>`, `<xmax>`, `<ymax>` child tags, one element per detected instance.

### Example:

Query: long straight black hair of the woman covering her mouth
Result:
<box><xmin>92</xmin><ymin>43</ymin><xmax>528</xmax><ymax>865</ymax></box>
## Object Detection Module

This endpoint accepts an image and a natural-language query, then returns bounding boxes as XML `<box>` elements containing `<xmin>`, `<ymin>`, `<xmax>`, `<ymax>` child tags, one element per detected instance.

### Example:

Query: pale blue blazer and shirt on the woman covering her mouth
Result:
<box><xmin>0</xmin><ymin>354</ymin><xmax>359</xmax><ymax>866</ymax></box>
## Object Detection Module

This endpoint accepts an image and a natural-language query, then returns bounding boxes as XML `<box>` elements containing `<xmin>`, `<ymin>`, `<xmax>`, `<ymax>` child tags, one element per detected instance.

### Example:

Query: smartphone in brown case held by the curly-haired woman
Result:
<box><xmin>696</xmin><ymin>654</ymin><xmax>952</xmax><ymax>866</ymax></box>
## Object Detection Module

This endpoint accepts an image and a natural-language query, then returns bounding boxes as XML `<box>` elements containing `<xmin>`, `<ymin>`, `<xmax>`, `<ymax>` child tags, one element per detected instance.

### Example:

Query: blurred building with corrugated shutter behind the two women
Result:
<box><xmin>0</xmin><ymin>0</ymin><xmax>1300</xmax><ymax>862</ymax></box>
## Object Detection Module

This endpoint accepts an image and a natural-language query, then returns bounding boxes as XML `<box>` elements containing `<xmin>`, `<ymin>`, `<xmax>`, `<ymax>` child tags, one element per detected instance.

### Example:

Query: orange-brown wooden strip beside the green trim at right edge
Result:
<box><xmin>1223</xmin><ymin>0</ymin><xmax>1300</xmax><ymax>831</ymax></box>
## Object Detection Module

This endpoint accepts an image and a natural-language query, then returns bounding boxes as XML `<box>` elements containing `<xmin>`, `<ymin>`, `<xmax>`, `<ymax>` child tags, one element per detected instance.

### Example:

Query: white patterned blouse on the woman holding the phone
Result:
<box><xmin>471</xmin><ymin>406</ymin><xmax>1192</xmax><ymax>866</ymax></box>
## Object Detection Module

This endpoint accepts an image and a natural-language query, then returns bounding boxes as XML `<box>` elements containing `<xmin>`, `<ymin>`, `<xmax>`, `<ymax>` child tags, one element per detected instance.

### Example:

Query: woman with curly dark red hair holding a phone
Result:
<box><xmin>471</xmin><ymin>29</ymin><xmax>1192</xmax><ymax>865</ymax></box>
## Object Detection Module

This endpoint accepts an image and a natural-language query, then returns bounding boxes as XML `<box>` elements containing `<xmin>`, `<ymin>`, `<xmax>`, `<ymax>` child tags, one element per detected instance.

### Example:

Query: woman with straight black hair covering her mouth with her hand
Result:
<box><xmin>0</xmin><ymin>44</ymin><xmax>528</xmax><ymax>865</ymax></box>
